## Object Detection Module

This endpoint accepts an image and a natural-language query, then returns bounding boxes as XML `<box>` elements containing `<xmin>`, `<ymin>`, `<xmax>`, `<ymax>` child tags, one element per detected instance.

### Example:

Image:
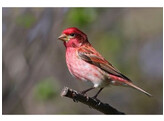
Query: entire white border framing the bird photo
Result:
<box><xmin>0</xmin><ymin>0</ymin><xmax>164</xmax><ymax>121</ymax></box>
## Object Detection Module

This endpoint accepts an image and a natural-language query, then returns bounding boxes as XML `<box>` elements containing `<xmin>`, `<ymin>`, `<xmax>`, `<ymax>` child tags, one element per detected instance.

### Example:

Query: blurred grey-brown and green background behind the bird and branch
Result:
<box><xmin>2</xmin><ymin>8</ymin><xmax>163</xmax><ymax>114</ymax></box>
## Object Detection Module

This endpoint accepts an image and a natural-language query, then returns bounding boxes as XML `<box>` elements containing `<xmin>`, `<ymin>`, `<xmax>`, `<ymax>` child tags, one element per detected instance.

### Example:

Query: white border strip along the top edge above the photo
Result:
<box><xmin>1</xmin><ymin>0</ymin><xmax>164</xmax><ymax>7</ymax></box>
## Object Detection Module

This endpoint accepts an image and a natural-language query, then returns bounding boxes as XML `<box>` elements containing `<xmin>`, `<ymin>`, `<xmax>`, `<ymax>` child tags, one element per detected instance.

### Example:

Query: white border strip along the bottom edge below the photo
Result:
<box><xmin>1</xmin><ymin>115</ymin><xmax>164</xmax><ymax>121</ymax></box>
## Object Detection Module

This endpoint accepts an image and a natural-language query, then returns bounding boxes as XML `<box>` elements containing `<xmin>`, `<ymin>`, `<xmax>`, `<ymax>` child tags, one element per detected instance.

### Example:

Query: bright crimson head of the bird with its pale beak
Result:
<box><xmin>58</xmin><ymin>27</ymin><xmax>88</xmax><ymax>47</ymax></box>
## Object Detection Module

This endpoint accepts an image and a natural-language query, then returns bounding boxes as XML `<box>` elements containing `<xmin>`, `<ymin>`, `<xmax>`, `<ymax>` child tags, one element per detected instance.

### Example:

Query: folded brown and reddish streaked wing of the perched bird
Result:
<box><xmin>77</xmin><ymin>46</ymin><xmax>131</xmax><ymax>82</ymax></box>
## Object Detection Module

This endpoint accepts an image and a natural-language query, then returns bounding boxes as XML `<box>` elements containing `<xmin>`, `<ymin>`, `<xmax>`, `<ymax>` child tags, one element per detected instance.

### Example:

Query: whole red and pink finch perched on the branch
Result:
<box><xmin>58</xmin><ymin>27</ymin><xmax>151</xmax><ymax>98</ymax></box>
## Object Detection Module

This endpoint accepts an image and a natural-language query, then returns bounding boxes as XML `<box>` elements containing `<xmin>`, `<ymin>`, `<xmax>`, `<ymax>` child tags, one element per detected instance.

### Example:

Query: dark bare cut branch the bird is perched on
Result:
<box><xmin>61</xmin><ymin>87</ymin><xmax>125</xmax><ymax>115</ymax></box>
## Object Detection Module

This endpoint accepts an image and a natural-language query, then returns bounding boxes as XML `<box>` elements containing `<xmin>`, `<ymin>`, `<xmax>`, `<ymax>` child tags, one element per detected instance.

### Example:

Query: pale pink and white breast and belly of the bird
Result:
<box><xmin>66</xmin><ymin>48</ymin><xmax>109</xmax><ymax>87</ymax></box>
